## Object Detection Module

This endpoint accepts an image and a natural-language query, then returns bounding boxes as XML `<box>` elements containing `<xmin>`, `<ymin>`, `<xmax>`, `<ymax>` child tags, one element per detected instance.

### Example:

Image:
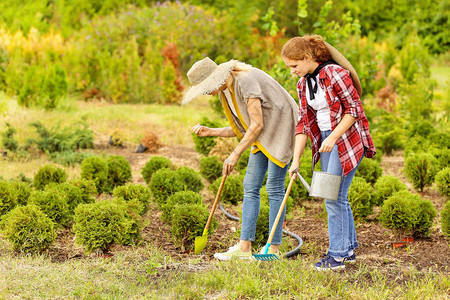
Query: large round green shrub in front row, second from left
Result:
<box><xmin>73</xmin><ymin>200</ymin><xmax>140</xmax><ymax>253</ymax></box>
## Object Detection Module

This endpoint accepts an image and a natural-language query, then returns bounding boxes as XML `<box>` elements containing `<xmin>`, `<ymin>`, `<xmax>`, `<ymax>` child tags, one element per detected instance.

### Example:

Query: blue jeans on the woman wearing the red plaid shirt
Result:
<box><xmin>320</xmin><ymin>130</ymin><xmax>364</xmax><ymax>258</ymax></box>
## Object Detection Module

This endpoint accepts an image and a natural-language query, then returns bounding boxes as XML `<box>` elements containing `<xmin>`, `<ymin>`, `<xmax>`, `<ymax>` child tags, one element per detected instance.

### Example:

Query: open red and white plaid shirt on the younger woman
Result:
<box><xmin>295</xmin><ymin>65</ymin><xmax>376</xmax><ymax>175</ymax></box>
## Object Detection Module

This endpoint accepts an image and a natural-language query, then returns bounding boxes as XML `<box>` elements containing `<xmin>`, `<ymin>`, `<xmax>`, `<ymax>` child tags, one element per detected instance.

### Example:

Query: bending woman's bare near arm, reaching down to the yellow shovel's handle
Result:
<box><xmin>222</xmin><ymin>98</ymin><xmax>264</xmax><ymax>175</ymax></box>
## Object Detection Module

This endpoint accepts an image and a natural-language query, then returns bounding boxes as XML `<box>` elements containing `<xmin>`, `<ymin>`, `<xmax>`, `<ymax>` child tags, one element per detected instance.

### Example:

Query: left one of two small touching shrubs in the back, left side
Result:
<box><xmin>81</xmin><ymin>156</ymin><xmax>108</xmax><ymax>194</ymax></box>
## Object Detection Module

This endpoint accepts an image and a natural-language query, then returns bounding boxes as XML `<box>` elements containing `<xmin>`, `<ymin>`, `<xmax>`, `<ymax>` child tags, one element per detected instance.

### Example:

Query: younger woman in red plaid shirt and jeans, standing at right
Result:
<box><xmin>281</xmin><ymin>35</ymin><xmax>376</xmax><ymax>270</ymax></box>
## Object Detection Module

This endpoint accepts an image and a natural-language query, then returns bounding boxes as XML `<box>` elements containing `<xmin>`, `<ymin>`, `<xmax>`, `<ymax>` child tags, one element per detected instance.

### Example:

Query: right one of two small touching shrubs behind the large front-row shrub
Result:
<box><xmin>105</xmin><ymin>155</ymin><xmax>132</xmax><ymax>192</ymax></box>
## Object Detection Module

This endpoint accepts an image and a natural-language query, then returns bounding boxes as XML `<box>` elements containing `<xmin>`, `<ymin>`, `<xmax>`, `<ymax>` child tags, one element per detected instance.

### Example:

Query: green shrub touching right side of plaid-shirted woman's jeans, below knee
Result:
<box><xmin>348</xmin><ymin>176</ymin><xmax>373</xmax><ymax>220</ymax></box>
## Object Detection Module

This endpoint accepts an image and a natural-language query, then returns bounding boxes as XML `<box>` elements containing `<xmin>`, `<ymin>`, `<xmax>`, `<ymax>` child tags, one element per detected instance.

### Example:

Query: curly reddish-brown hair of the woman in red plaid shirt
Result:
<box><xmin>281</xmin><ymin>35</ymin><xmax>331</xmax><ymax>62</ymax></box>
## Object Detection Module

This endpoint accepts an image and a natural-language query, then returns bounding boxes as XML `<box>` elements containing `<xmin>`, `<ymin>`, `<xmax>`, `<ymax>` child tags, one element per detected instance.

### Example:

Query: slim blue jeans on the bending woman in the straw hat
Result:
<box><xmin>241</xmin><ymin>151</ymin><xmax>288</xmax><ymax>245</ymax></box>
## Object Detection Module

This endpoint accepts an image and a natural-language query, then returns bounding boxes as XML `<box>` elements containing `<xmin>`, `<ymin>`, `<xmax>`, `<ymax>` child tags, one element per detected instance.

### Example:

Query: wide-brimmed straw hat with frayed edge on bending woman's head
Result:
<box><xmin>182</xmin><ymin>57</ymin><xmax>239</xmax><ymax>104</ymax></box>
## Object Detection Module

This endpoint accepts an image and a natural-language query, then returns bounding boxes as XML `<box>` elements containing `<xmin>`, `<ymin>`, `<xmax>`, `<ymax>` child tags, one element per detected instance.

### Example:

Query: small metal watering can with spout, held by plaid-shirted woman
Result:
<box><xmin>297</xmin><ymin>152</ymin><xmax>345</xmax><ymax>200</ymax></box>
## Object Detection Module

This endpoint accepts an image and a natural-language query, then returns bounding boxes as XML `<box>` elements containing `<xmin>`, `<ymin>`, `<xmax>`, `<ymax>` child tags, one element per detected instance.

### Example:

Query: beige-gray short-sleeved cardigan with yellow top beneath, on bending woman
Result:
<box><xmin>220</xmin><ymin>67</ymin><xmax>299</xmax><ymax>167</ymax></box>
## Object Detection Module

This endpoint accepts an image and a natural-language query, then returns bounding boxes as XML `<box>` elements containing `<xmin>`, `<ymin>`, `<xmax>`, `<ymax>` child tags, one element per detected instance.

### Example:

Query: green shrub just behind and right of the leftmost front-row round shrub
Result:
<box><xmin>28</xmin><ymin>185</ymin><xmax>72</xmax><ymax>227</ymax></box>
